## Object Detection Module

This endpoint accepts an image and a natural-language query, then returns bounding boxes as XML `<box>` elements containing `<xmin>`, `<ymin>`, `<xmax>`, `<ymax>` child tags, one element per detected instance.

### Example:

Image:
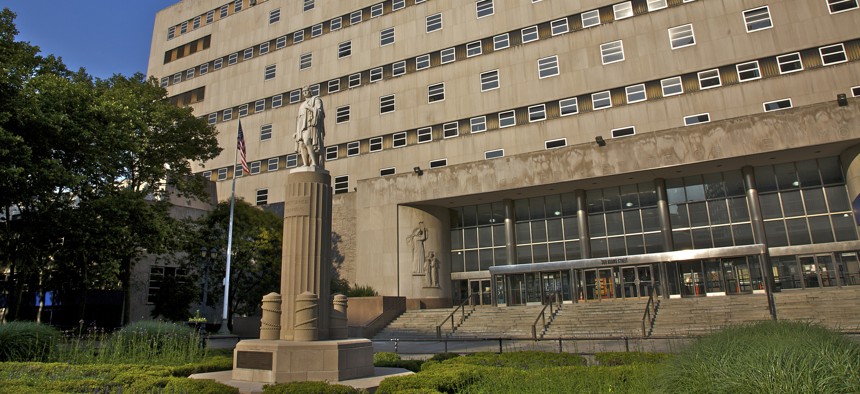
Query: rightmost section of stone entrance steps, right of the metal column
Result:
<box><xmin>773</xmin><ymin>286</ymin><xmax>860</xmax><ymax>332</ymax></box>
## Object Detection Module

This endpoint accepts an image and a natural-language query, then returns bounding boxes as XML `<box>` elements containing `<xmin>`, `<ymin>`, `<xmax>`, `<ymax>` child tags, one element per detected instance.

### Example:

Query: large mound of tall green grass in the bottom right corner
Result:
<box><xmin>654</xmin><ymin>321</ymin><xmax>860</xmax><ymax>393</ymax></box>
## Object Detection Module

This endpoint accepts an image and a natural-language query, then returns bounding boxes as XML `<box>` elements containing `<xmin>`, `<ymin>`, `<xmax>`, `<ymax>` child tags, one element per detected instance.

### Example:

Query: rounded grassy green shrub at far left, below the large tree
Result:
<box><xmin>0</xmin><ymin>322</ymin><xmax>60</xmax><ymax>361</ymax></box>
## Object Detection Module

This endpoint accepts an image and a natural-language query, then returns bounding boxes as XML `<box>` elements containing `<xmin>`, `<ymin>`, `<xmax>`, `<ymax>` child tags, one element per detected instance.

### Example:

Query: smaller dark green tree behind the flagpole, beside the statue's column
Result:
<box><xmin>185</xmin><ymin>199</ymin><xmax>283</xmax><ymax>330</ymax></box>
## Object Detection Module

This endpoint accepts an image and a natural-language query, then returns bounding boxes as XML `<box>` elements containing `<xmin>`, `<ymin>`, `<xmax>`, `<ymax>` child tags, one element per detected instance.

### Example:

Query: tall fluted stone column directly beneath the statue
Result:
<box><xmin>281</xmin><ymin>167</ymin><xmax>332</xmax><ymax>341</ymax></box>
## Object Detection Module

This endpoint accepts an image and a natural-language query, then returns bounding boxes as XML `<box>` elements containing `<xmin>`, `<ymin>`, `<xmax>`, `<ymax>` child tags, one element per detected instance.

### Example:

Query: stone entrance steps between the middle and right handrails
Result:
<box><xmin>538</xmin><ymin>299</ymin><xmax>648</xmax><ymax>338</ymax></box>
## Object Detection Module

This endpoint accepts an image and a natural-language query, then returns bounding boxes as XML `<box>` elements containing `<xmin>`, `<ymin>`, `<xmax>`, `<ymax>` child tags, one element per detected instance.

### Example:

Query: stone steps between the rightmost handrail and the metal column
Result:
<box><xmin>651</xmin><ymin>294</ymin><xmax>771</xmax><ymax>337</ymax></box>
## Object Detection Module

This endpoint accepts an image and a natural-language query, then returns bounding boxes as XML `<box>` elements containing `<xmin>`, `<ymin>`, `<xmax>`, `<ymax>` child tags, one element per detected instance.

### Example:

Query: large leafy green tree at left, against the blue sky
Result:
<box><xmin>0</xmin><ymin>9</ymin><xmax>220</xmax><ymax>324</ymax></box>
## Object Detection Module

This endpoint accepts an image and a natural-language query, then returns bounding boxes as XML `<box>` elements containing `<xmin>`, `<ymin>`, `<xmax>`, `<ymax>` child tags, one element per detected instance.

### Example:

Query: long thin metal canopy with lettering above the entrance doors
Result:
<box><xmin>490</xmin><ymin>244</ymin><xmax>766</xmax><ymax>275</ymax></box>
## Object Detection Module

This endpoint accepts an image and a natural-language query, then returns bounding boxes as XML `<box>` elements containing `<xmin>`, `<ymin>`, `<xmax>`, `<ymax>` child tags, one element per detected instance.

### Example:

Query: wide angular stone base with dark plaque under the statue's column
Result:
<box><xmin>233</xmin><ymin>339</ymin><xmax>374</xmax><ymax>383</ymax></box>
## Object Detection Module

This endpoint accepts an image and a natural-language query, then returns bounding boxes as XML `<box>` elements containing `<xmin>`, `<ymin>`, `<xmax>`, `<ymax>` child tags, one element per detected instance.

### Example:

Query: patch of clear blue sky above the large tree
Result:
<box><xmin>0</xmin><ymin>0</ymin><xmax>179</xmax><ymax>78</ymax></box>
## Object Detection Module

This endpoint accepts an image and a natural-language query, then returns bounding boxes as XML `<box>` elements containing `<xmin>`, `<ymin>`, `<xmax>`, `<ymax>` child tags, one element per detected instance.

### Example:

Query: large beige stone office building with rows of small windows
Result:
<box><xmin>149</xmin><ymin>0</ymin><xmax>860</xmax><ymax>307</ymax></box>
